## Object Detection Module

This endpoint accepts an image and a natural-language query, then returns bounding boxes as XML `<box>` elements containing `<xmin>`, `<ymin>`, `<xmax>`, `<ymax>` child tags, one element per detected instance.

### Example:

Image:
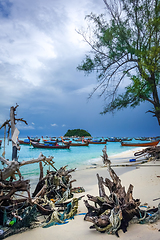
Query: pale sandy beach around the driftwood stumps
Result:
<box><xmin>7</xmin><ymin>149</ymin><xmax>160</xmax><ymax>240</ymax></box>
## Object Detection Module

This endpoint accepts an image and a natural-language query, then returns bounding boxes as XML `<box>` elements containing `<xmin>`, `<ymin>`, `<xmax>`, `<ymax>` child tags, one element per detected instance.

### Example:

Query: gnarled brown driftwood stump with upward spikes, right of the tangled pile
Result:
<box><xmin>84</xmin><ymin>148</ymin><xmax>160</xmax><ymax>236</ymax></box>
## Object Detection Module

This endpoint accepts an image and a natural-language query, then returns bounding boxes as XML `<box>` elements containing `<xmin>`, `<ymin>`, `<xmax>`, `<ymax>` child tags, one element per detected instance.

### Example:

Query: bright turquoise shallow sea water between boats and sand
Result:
<box><xmin>0</xmin><ymin>138</ymin><xmax>139</xmax><ymax>178</ymax></box>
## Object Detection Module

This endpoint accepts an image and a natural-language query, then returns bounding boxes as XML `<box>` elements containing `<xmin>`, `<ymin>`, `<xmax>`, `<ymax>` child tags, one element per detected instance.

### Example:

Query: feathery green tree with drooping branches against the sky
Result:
<box><xmin>78</xmin><ymin>0</ymin><xmax>160</xmax><ymax>125</ymax></box>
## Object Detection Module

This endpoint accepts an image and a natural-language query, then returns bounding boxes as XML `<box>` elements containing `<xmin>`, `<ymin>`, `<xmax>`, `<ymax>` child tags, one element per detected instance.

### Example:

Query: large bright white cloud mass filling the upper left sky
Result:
<box><xmin>0</xmin><ymin>0</ymin><xmax>103</xmax><ymax>109</ymax></box>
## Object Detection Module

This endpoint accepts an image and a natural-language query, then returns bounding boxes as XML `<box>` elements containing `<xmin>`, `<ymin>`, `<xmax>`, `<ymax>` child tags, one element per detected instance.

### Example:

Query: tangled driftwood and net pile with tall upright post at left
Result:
<box><xmin>0</xmin><ymin>105</ymin><xmax>84</xmax><ymax>239</ymax></box>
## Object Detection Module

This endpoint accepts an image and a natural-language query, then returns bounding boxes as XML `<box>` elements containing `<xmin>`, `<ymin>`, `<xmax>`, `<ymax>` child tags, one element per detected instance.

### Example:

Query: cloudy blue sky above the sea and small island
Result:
<box><xmin>0</xmin><ymin>0</ymin><xmax>160</xmax><ymax>137</ymax></box>
